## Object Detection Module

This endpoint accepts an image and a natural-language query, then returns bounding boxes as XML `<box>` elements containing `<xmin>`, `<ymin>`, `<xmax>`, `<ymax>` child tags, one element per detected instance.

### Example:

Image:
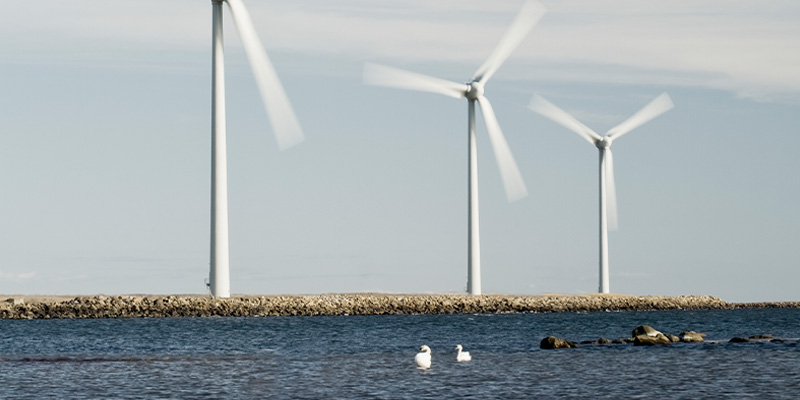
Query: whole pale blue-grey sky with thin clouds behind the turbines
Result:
<box><xmin>0</xmin><ymin>0</ymin><xmax>800</xmax><ymax>301</ymax></box>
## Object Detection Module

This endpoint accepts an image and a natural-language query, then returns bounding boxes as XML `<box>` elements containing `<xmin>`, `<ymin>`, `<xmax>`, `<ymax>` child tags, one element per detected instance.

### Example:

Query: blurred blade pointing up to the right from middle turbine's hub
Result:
<box><xmin>472</xmin><ymin>0</ymin><xmax>547</xmax><ymax>83</ymax></box>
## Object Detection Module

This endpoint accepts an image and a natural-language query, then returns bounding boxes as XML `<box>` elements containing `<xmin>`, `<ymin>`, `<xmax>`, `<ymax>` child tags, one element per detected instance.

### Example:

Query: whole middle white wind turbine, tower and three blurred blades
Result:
<box><xmin>364</xmin><ymin>1</ymin><xmax>546</xmax><ymax>295</ymax></box>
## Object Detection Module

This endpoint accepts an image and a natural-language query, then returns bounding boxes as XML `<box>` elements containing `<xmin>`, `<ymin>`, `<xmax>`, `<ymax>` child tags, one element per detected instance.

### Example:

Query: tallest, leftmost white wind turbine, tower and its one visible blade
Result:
<box><xmin>208</xmin><ymin>0</ymin><xmax>303</xmax><ymax>297</ymax></box>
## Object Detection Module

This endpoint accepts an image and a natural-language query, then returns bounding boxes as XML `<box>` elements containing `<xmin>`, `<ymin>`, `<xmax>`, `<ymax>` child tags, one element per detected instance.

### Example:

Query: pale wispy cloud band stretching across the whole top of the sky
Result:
<box><xmin>0</xmin><ymin>0</ymin><xmax>800</xmax><ymax>100</ymax></box>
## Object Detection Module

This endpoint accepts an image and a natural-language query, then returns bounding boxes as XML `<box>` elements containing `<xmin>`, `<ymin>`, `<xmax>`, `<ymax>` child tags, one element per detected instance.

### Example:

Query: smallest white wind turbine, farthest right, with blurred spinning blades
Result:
<box><xmin>529</xmin><ymin>93</ymin><xmax>673</xmax><ymax>293</ymax></box>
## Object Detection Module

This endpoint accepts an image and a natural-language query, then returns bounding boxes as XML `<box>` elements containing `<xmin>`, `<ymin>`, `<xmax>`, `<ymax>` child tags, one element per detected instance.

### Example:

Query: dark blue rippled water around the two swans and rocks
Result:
<box><xmin>0</xmin><ymin>309</ymin><xmax>800</xmax><ymax>399</ymax></box>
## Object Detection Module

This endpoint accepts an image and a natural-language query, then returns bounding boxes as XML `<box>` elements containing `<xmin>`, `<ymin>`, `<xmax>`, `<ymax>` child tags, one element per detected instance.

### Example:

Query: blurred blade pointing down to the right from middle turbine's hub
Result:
<box><xmin>478</xmin><ymin>96</ymin><xmax>528</xmax><ymax>203</ymax></box>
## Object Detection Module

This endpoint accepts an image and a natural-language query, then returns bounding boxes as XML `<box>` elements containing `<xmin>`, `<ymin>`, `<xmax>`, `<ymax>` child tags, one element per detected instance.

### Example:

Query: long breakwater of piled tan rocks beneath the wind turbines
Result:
<box><xmin>0</xmin><ymin>294</ymin><xmax>732</xmax><ymax>319</ymax></box>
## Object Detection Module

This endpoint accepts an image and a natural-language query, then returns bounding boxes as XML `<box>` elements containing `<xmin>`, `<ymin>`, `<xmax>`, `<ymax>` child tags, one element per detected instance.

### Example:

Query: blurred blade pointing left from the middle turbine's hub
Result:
<box><xmin>364</xmin><ymin>63</ymin><xmax>469</xmax><ymax>99</ymax></box>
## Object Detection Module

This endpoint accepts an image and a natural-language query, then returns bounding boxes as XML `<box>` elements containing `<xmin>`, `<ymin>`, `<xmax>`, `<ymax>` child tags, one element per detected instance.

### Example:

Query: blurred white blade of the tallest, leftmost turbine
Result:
<box><xmin>227</xmin><ymin>0</ymin><xmax>304</xmax><ymax>150</ymax></box>
